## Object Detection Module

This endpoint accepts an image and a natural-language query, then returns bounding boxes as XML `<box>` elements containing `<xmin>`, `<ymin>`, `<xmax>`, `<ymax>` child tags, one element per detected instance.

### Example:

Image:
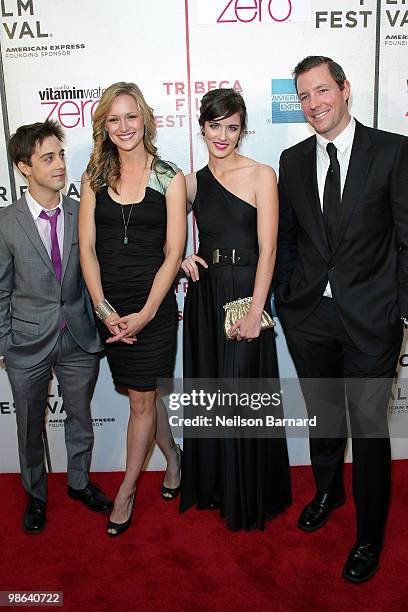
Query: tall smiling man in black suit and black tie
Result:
<box><xmin>275</xmin><ymin>56</ymin><xmax>408</xmax><ymax>582</ymax></box>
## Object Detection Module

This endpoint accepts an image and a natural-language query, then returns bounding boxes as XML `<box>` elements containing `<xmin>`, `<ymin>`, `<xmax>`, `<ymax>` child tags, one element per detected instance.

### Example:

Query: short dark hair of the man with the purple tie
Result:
<box><xmin>8</xmin><ymin>119</ymin><xmax>64</xmax><ymax>166</ymax></box>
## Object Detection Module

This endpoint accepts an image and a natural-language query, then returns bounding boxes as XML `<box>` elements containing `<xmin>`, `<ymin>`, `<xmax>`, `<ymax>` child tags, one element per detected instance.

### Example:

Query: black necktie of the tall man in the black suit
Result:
<box><xmin>323</xmin><ymin>142</ymin><xmax>341</xmax><ymax>247</ymax></box>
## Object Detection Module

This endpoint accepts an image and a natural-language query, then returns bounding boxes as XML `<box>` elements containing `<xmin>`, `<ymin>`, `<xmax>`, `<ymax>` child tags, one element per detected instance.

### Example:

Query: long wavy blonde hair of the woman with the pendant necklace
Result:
<box><xmin>86</xmin><ymin>81</ymin><xmax>158</xmax><ymax>192</ymax></box>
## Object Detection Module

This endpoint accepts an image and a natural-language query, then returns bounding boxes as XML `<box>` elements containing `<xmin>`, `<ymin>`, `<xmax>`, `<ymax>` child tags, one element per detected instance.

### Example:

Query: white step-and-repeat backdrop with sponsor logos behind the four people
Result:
<box><xmin>0</xmin><ymin>0</ymin><xmax>408</xmax><ymax>472</ymax></box>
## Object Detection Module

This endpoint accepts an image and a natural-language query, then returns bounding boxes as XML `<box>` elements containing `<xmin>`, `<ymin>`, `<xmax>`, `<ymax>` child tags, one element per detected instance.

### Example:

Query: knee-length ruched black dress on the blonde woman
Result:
<box><xmin>95</xmin><ymin>160</ymin><xmax>179</xmax><ymax>390</ymax></box>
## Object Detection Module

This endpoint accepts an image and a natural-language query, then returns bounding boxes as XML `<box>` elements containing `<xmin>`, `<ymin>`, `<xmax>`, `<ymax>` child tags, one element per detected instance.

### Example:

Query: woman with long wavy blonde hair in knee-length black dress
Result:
<box><xmin>79</xmin><ymin>83</ymin><xmax>186</xmax><ymax>536</ymax></box>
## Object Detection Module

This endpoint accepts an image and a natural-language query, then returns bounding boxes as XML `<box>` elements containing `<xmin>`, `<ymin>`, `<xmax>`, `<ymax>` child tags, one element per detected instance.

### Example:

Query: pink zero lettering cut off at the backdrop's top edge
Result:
<box><xmin>217</xmin><ymin>0</ymin><xmax>292</xmax><ymax>23</ymax></box>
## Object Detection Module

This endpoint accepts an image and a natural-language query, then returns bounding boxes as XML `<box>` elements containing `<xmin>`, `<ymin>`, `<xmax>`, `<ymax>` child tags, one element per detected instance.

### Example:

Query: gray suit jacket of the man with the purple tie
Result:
<box><xmin>0</xmin><ymin>196</ymin><xmax>102</xmax><ymax>368</ymax></box>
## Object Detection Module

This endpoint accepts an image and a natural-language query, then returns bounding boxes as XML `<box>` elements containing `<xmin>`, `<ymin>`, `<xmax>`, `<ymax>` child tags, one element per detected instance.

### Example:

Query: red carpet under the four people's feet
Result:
<box><xmin>0</xmin><ymin>461</ymin><xmax>408</xmax><ymax>612</ymax></box>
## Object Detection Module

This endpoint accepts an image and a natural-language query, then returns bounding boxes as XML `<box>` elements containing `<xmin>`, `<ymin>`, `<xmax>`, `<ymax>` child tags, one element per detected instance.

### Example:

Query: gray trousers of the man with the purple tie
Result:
<box><xmin>5</xmin><ymin>329</ymin><xmax>99</xmax><ymax>501</ymax></box>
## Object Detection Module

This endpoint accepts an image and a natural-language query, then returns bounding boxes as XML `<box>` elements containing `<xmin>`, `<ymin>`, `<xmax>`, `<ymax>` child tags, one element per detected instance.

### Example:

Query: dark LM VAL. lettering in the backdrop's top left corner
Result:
<box><xmin>0</xmin><ymin>0</ymin><xmax>52</xmax><ymax>40</ymax></box>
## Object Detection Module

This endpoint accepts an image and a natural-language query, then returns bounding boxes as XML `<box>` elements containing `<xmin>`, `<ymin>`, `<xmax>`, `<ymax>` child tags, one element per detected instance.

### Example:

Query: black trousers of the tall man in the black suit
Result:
<box><xmin>285</xmin><ymin>297</ymin><xmax>403</xmax><ymax>546</ymax></box>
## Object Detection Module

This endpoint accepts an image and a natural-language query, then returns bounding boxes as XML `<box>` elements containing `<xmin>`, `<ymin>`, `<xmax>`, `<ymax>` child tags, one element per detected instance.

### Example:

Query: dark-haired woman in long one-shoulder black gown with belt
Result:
<box><xmin>180</xmin><ymin>89</ymin><xmax>291</xmax><ymax>530</ymax></box>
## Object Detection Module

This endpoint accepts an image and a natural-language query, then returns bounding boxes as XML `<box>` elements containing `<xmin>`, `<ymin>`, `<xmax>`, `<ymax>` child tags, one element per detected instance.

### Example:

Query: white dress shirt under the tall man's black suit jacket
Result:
<box><xmin>316</xmin><ymin>117</ymin><xmax>356</xmax><ymax>297</ymax></box>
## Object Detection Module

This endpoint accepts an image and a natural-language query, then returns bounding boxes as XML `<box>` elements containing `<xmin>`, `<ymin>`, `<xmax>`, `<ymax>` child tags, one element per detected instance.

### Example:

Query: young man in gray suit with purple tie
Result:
<box><xmin>0</xmin><ymin>121</ymin><xmax>112</xmax><ymax>533</ymax></box>
